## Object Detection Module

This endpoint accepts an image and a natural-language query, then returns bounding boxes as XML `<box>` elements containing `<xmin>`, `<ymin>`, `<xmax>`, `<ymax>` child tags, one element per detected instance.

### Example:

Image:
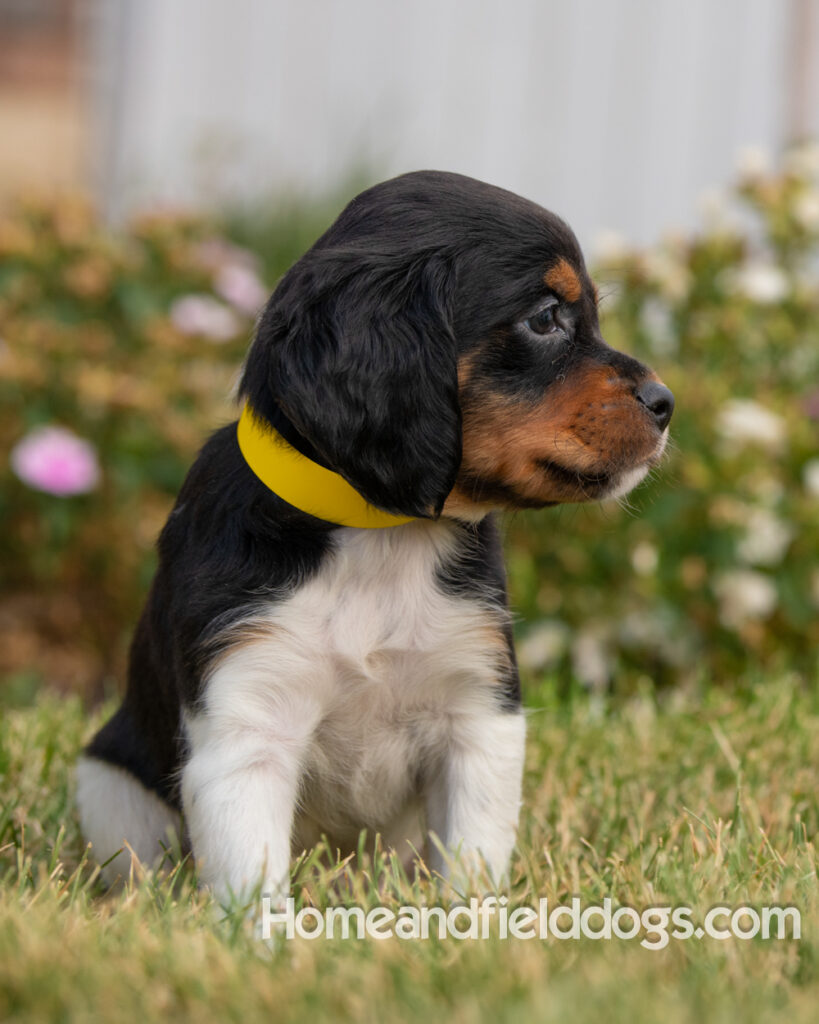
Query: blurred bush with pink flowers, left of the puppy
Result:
<box><xmin>0</xmin><ymin>200</ymin><xmax>265</xmax><ymax>689</ymax></box>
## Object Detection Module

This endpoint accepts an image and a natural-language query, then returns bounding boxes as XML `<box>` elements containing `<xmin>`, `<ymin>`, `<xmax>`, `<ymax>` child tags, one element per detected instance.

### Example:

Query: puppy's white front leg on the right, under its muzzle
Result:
<box><xmin>427</xmin><ymin>711</ymin><xmax>526</xmax><ymax>888</ymax></box>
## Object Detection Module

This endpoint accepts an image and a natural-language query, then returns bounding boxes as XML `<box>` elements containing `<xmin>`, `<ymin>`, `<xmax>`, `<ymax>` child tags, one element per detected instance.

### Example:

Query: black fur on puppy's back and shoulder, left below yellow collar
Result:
<box><xmin>88</xmin><ymin>423</ymin><xmax>335</xmax><ymax>807</ymax></box>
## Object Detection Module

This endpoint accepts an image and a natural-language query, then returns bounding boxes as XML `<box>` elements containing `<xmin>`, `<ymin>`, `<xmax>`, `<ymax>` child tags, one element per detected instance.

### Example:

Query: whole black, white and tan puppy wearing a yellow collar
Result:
<box><xmin>78</xmin><ymin>171</ymin><xmax>674</xmax><ymax>899</ymax></box>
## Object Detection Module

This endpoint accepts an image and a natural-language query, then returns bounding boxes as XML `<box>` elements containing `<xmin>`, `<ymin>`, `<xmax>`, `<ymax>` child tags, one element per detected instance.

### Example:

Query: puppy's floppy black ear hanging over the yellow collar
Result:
<box><xmin>241</xmin><ymin>247</ymin><xmax>461</xmax><ymax>517</ymax></box>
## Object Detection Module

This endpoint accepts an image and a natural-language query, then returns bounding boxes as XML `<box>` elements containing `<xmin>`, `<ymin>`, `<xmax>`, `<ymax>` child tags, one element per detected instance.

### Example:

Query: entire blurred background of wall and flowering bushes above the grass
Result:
<box><xmin>0</xmin><ymin>0</ymin><xmax>819</xmax><ymax>703</ymax></box>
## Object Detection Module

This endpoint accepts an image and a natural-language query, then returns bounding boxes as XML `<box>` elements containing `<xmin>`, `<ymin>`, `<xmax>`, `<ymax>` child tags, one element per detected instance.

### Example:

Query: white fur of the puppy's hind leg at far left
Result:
<box><xmin>77</xmin><ymin>757</ymin><xmax>179</xmax><ymax>885</ymax></box>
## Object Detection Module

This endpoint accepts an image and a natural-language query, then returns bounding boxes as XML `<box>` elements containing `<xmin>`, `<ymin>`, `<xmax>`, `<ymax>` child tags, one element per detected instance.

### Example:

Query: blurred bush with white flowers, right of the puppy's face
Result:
<box><xmin>509</xmin><ymin>144</ymin><xmax>819</xmax><ymax>688</ymax></box>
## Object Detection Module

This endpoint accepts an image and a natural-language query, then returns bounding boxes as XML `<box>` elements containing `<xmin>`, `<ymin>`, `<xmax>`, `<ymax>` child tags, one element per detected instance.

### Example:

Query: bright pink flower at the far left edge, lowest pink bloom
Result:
<box><xmin>10</xmin><ymin>427</ymin><xmax>99</xmax><ymax>497</ymax></box>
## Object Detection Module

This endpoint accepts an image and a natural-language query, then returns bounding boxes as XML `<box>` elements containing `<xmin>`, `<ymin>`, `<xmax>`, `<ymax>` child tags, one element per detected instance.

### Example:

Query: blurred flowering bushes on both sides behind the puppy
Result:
<box><xmin>0</xmin><ymin>145</ymin><xmax>819</xmax><ymax>691</ymax></box>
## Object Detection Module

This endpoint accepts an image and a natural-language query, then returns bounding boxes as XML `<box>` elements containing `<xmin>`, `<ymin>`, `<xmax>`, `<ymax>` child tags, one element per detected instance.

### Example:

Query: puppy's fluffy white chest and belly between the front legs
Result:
<box><xmin>262</xmin><ymin>524</ymin><xmax>502</xmax><ymax>837</ymax></box>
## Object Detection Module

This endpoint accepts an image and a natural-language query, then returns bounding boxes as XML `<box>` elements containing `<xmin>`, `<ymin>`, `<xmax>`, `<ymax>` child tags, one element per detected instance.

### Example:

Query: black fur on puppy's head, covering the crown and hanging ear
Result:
<box><xmin>241</xmin><ymin>171</ymin><xmax>581</xmax><ymax>517</ymax></box>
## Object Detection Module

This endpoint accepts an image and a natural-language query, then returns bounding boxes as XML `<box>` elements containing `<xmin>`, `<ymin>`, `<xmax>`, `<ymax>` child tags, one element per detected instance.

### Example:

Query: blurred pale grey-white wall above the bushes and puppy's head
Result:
<box><xmin>91</xmin><ymin>0</ymin><xmax>819</xmax><ymax>244</ymax></box>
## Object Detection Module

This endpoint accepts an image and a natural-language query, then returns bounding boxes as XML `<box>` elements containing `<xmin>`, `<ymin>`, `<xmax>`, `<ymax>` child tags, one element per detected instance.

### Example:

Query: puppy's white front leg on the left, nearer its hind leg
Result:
<box><xmin>181</xmin><ymin>658</ymin><xmax>320</xmax><ymax>904</ymax></box>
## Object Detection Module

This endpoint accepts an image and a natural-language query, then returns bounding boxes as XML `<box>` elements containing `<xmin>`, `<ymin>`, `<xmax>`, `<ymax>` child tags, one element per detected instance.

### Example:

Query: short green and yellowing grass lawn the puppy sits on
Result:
<box><xmin>0</xmin><ymin>675</ymin><xmax>819</xmax><ymax>1024</ymax></box>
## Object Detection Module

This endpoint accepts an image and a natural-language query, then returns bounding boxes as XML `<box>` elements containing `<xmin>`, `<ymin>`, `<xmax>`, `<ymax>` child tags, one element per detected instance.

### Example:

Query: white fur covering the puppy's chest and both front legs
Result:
<box><xmin>181</xmin><ymin>522</ymin><xmax>525</xmax><ymax>899</ymax></box>
